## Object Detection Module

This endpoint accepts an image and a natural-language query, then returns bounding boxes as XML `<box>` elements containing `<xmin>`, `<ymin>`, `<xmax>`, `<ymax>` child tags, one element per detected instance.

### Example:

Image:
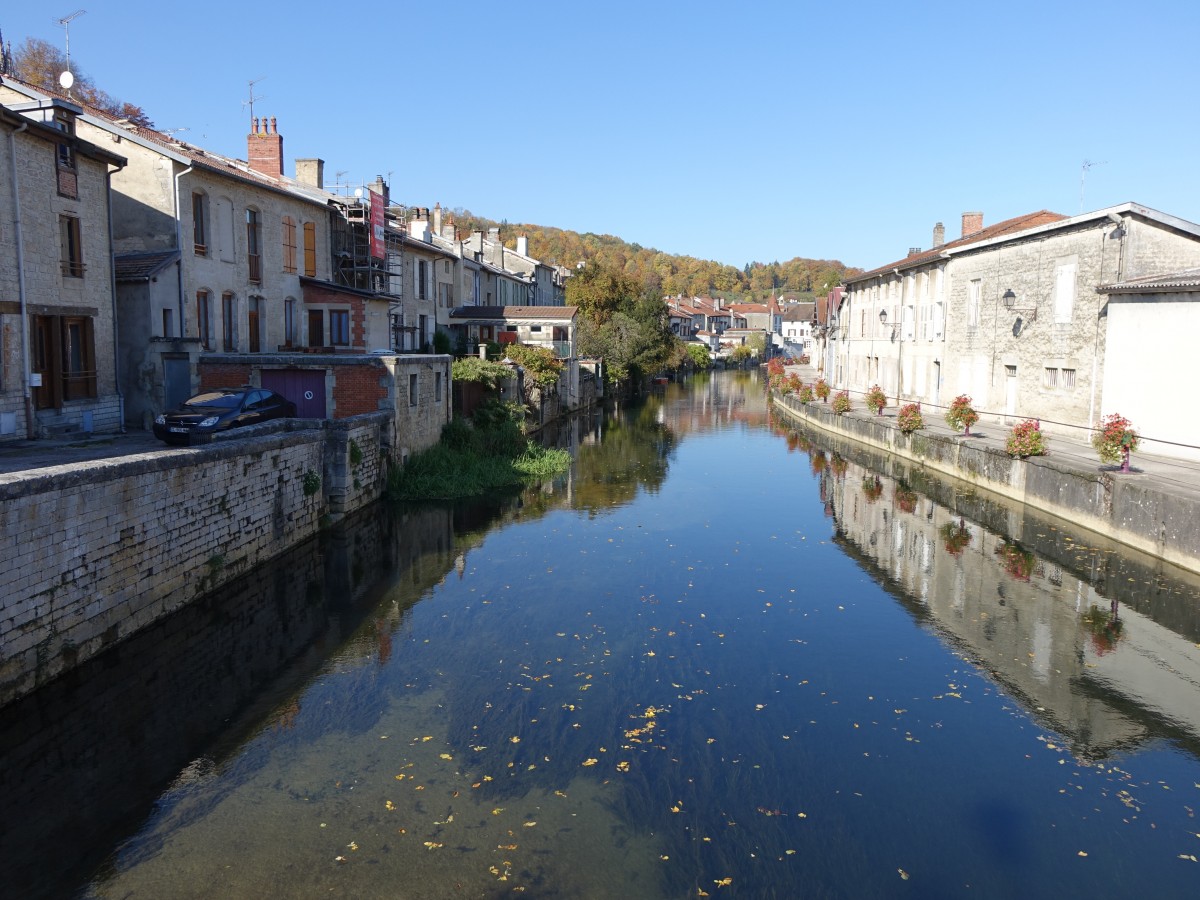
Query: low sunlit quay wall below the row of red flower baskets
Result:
<box><xmin>774</xmin><ymin>396</ymin><xmax>1200</xmax><ymax>572</ymax></box>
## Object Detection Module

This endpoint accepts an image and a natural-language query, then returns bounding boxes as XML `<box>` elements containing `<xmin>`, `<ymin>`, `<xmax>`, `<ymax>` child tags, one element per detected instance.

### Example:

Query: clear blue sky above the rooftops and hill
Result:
<box><xmin>0</xmin><ymin>0</ymin><xmax>1200</xmax><ymax>268</ymax></box>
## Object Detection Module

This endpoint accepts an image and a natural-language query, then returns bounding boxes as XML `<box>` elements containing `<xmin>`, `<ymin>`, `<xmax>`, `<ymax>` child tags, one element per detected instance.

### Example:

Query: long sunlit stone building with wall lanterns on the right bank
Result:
<box><xmin>830</xmin><ymin>203</ymin><xmax>1200</xmax><ymax>448</ymax></box>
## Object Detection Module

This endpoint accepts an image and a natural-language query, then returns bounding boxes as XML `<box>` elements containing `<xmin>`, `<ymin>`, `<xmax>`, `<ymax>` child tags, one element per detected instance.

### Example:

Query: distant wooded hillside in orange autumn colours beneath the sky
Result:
<box><xmin>452</xmin><ymin>209</ymin><xmax>862</xmax><ymax>301</ymax></box>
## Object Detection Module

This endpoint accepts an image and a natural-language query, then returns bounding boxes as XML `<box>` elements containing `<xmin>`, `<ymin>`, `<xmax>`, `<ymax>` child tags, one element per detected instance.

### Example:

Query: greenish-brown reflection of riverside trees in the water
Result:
<box><xmin>572</xmin><ymin>398</ymin><xmax>677</xmax><ymax>514</ymax></box>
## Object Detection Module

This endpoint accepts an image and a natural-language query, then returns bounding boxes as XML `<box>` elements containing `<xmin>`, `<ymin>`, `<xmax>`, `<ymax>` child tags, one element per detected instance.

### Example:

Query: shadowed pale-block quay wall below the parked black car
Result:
<box><xmin>0</xmin><ymin>413</ymin><xmax>394</xmax><ymax>706</ymax></box>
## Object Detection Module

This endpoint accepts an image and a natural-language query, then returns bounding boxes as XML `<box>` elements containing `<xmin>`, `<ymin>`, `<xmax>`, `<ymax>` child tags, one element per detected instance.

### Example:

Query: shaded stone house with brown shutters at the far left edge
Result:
<box><xmin>0</xmin><ymin>97</ymin><xmax>125</xmax><ymax>442</ymax></box>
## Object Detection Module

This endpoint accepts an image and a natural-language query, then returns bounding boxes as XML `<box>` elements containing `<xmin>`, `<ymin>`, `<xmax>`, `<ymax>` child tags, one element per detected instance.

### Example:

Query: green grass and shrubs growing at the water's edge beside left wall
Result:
<box><xmin>388</xmin><ymin>403</ymin><xmax>571</xmax><ymax>500</ymax></box>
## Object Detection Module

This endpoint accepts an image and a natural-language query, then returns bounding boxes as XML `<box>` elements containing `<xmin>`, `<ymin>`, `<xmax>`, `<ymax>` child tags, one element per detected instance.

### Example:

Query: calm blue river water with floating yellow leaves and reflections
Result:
<box><xmin>0</xmin><ymin>373</ymin><xmax>1200</xmax><ymax>900</ymax></box>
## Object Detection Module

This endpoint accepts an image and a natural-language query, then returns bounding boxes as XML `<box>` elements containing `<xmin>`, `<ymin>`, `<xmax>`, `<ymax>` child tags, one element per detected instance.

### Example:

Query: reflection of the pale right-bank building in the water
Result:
<box><xmin>830</xmin><ymin>451</ymin><xmax>1200</xmax><ymax>757</ymax></box>
